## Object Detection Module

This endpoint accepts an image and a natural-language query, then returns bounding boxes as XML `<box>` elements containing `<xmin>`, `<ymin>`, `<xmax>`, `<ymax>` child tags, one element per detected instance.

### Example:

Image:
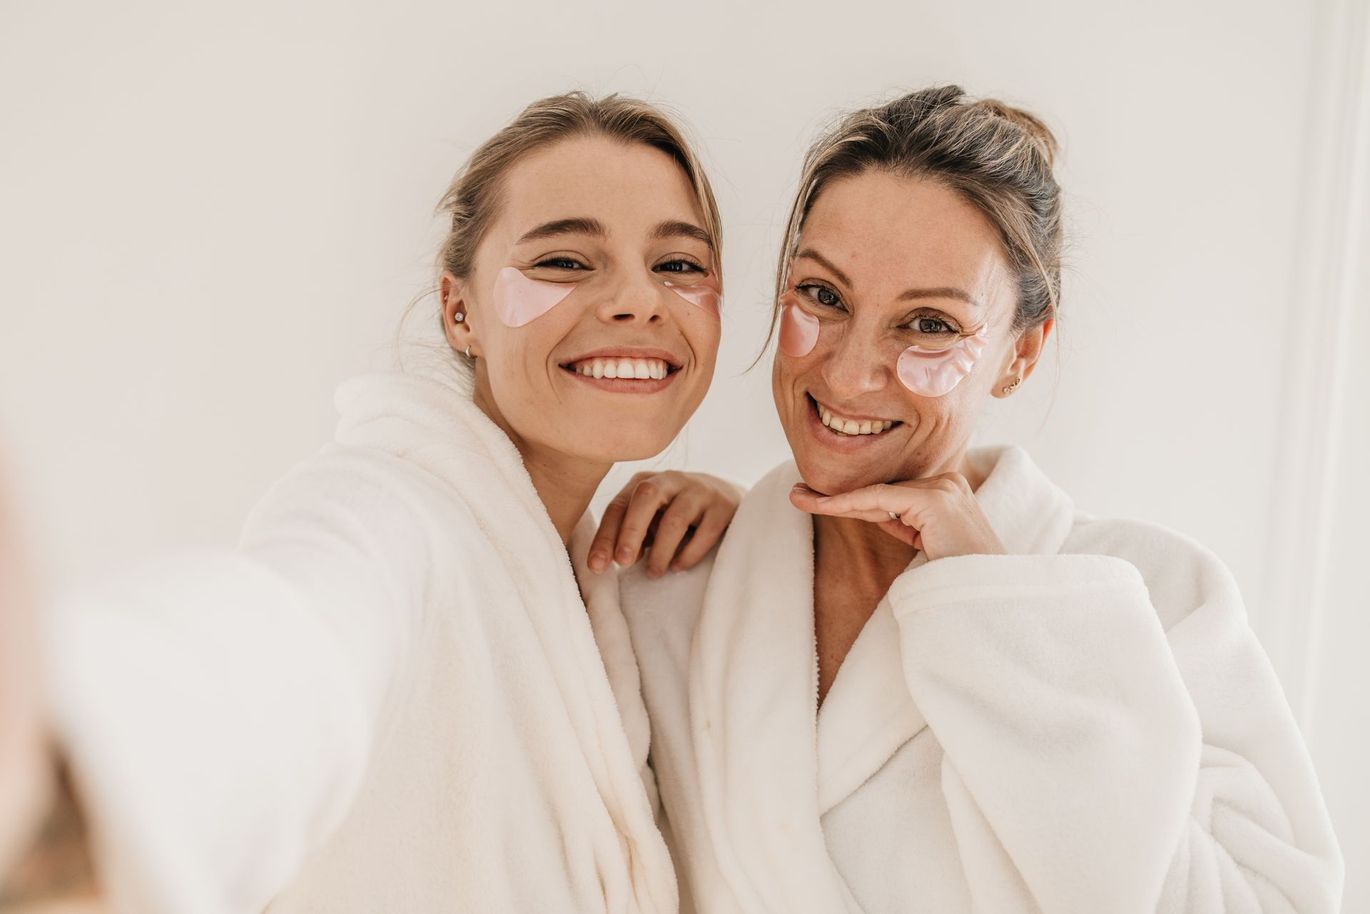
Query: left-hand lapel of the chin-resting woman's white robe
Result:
<box><xmin>689</xmin><ymin>463</ymin><xmax>859</xmax><ymax>914</ymax></box>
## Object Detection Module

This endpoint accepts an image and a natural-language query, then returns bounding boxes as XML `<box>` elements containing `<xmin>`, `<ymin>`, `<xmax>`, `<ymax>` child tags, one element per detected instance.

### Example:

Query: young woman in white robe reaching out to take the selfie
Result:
<box><xmin>0</xmin><ymin>93</ymin><xmax>733</xmax><ymax>914</ymax></box>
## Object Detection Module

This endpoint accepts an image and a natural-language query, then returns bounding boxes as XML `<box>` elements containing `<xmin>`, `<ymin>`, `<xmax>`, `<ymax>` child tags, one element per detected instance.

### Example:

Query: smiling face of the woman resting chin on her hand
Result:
<box><xmin>771</xmin><ymin>171</ymin><xmax>1051</xmax><ymax>493</ymax></box>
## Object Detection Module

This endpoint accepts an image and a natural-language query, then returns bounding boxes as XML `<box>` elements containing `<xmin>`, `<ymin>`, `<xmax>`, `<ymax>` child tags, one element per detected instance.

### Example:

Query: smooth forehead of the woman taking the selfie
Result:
<box><xmin>492</xmin><ymin>137</ymin><xmax>703</xmax><ymax>238</ymax></box>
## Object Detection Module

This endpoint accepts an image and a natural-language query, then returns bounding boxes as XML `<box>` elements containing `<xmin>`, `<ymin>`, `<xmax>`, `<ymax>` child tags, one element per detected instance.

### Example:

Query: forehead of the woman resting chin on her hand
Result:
<box><xmin>799</xmin><ymin>171</ymin><xmax>1008</xmax><ymax>300</ymax></box>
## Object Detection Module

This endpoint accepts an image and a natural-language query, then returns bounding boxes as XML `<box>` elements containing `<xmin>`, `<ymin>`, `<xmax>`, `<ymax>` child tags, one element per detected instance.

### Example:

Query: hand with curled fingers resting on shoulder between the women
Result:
<box><xmin>589</xmin><ymin>470</ymin><xmax>743</xmax><ymax>577</ymax></box>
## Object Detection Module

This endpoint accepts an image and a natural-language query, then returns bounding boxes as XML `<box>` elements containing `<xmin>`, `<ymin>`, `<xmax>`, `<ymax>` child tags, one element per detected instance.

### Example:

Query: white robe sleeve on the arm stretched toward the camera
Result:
<box><xmin>45</xmin><ymin>448</ymin><xmax>430</xmax><ymax>914</ymax></box>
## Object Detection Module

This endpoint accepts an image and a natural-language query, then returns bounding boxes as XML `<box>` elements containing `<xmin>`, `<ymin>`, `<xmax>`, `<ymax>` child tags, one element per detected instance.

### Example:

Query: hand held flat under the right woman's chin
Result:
<box><xmin>789</xmin><ymin>473</ymin><xmax>1006</xmax><ymax>559</ymax></box>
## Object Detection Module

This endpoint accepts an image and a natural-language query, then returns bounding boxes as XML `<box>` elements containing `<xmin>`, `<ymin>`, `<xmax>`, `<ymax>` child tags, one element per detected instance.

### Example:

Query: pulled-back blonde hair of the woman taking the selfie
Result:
<box><xmin>437</xmin><ymin>92</ymin><xmax>723</xmax><ymax>286</ymax></box>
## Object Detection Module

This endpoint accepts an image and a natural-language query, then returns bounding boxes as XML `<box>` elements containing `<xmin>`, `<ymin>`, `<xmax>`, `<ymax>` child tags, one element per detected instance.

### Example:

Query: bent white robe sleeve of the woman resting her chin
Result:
<box><xmin>891</xmin><ymin>534</ymin><xmax>1343</xmax><ymax>914</ymax></box>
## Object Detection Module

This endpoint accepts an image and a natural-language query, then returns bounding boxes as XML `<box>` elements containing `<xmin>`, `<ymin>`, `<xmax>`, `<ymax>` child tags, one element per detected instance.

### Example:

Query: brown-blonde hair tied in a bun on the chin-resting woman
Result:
<box><xmin>767</xmin><ymin>85</ymin><xmax>1063</xmax><ymax>344</ymax></box>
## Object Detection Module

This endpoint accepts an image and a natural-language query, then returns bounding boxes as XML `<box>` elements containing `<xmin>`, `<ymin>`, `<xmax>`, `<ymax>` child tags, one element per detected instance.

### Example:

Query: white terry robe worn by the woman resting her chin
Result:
<box><xmin>621</xmin><ymin>447</ymin><xmax>1343</xmax><ymax>914</ymax></box>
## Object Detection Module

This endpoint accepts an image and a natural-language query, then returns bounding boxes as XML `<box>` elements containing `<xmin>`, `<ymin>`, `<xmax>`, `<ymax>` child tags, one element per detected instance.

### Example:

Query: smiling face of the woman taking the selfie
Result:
<box><xmin>441</xmin><ymin>136</ymin><xmax>722</xmax><ymax>463</ymax></box>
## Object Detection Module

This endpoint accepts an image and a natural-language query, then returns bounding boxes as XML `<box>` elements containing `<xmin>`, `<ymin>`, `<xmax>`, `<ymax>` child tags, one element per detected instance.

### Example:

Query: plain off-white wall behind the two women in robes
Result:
<box><xmin>0</xmin><ymin>0</ymin><xmax>1370</xmax><ymax>911</ymax></box>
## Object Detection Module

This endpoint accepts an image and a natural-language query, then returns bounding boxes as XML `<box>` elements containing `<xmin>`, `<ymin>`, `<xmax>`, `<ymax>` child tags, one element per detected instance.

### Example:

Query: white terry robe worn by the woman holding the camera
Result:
<box><xmin>48</xmin><ymin>375</ymin><xmax>677</xmax><ymax>914</ymax></box>
